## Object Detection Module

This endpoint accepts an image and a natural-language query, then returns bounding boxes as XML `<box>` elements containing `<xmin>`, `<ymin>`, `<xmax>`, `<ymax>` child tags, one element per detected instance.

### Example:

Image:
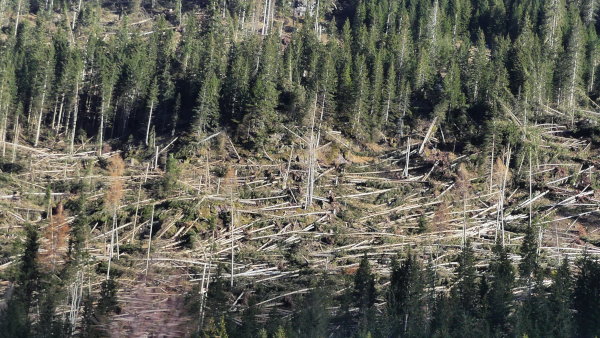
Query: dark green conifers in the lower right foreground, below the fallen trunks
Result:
<box><xmin>189</xmin><ymin>243</ymin><xmax>600</xmax><ymax>337</ymax></box>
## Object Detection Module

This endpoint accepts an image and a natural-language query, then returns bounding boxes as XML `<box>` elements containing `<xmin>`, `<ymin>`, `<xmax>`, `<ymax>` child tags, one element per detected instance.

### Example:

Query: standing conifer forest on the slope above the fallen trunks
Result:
<box><xmin>0</xmin><ymin>0</ymin><xmax>599</xmax><ymax>154</ymax></box>
